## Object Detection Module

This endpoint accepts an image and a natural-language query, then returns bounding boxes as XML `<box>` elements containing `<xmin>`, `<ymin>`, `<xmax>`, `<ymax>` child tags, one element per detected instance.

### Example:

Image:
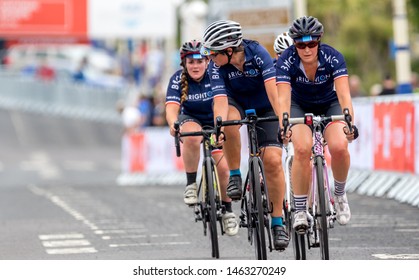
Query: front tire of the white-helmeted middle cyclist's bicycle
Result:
<box><xmin>250</xmin><ymin>158</ymin><xmax>268</xmax><ymax>260</ymax></box>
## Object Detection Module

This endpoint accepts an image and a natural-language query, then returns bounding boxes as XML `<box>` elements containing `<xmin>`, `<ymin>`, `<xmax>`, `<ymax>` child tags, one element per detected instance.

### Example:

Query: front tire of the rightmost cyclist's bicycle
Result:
<box><xmin>314</xmin><ymin>156</ymin><xmax>329</xmax><ymax>260</ymax></box>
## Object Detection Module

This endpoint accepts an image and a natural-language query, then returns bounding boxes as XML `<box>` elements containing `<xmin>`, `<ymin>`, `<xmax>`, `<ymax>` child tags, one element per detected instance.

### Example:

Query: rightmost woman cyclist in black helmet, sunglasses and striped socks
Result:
<box><xmin>276</xmin><ymin>16</ymin><xmax>358</xmax><ymax>230</ymax></box>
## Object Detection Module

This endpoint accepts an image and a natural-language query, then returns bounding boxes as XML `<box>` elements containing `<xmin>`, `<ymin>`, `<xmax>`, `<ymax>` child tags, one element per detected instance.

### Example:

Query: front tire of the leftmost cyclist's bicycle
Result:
<box><xmin>204</xmin><ymin>158</ymin><xmax>220</xmax><ymax>259</ymax></box>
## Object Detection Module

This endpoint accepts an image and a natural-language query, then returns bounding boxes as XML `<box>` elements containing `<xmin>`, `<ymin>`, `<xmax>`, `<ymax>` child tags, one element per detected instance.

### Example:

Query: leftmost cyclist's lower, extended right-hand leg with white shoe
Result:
<box><xmin>212</xmin><ymin>149</ymin><xmax>239</xmax><ymax>236</ymax></box>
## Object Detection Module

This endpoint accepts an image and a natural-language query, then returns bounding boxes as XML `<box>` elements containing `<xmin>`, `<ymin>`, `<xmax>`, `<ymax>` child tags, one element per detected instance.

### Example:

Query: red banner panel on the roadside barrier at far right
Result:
<box><xmin>374</xmin><ymin>102</ymin><xmax>415</xmax><ymax>173</ymax></box>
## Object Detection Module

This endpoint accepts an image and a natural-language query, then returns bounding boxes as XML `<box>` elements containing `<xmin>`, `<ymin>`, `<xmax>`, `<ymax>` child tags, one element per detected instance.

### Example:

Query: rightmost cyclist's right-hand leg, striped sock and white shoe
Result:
<box><xmin>324</xmin><ymin>103</ymin><xmax>351</xmax><ymax>225</ymax></box>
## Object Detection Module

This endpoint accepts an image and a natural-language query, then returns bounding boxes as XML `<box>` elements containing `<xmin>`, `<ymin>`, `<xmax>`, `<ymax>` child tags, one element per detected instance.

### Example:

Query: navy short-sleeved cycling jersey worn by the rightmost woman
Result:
<box><xmin>276</xmin><ymin>43</ymin><xmax>348</xmax><ymax>108</ymax></box>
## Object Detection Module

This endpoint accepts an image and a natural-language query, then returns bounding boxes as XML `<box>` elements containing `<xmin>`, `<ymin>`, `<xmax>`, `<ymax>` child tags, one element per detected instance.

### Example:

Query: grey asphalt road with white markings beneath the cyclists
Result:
<box><xmin>0</xmin><ymin>109</ymin><xmax>419</xmax><ymax>260</ymax></box>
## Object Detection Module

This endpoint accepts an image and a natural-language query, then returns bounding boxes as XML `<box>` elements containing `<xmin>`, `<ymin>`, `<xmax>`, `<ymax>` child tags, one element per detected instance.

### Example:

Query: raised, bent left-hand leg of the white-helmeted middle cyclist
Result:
<box><xmin>223</xmin><ymin>98</ymin><xmax>244</xmax><ymax>200</ymax></box>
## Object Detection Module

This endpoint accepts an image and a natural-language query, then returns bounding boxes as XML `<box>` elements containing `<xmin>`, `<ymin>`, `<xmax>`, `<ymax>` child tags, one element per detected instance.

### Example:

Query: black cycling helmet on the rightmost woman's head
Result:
<box><xmin>288</xmin><ymin>16</ymin><xmax>323</xmax><ymax>41</ymax></box>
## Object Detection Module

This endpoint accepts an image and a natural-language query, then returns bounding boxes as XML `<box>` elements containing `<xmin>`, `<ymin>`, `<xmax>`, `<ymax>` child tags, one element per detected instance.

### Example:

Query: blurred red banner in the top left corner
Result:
<box><xmin>0</xmin><ymin>0</ymin><xmax>87</xmax><ymax>37</ymax></box>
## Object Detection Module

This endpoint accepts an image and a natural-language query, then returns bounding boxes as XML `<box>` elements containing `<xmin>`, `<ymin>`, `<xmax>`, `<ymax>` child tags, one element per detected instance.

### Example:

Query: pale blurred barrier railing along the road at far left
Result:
<box><xmin>0</xmin><ymin>68</ymin><xmax>129</xmax><ymax>122</ymax></box>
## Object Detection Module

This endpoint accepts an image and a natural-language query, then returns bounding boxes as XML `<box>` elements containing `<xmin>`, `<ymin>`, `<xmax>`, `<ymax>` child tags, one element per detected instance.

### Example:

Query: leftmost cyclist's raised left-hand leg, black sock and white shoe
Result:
<box><xmin>179</xmin><ymin>115</ymin><xmax>202</xmax><ymax>205</ymax></box>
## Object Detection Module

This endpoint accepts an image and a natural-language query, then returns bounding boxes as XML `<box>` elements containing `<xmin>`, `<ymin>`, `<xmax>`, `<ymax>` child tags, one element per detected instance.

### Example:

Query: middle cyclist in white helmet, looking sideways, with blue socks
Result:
<box><xmin>201</xmin><ymin>20</ymin><xmax>289</xmax><ymax>250</ymax></box>
